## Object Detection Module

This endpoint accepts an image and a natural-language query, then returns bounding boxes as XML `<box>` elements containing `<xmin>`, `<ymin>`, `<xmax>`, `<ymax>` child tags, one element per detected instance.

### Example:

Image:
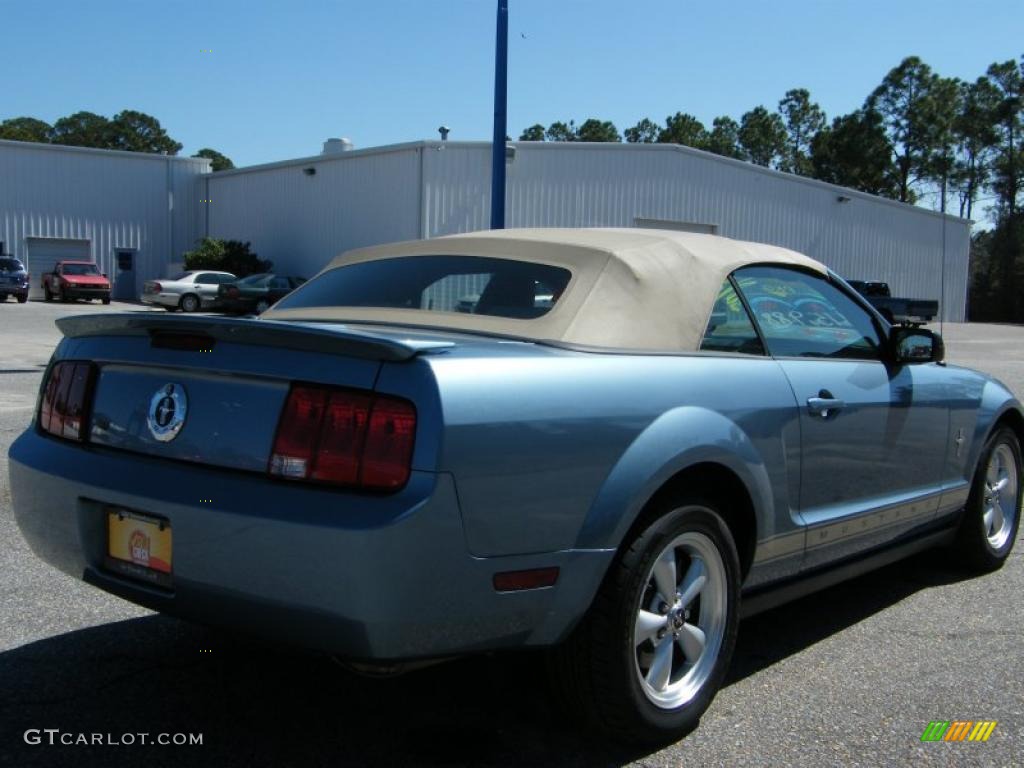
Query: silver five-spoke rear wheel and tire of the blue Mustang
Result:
<box><xmin>551</xmin><ymin>498</ymin><xmax>740</xmax><ymax>743</ymax></box>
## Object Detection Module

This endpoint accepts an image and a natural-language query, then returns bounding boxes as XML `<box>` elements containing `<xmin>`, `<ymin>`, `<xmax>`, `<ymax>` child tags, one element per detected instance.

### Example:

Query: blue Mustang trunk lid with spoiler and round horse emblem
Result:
<box><xmin>57</xmin><ymin>313</ymin><xmax>452</xmax><ymax>473</ymax></box>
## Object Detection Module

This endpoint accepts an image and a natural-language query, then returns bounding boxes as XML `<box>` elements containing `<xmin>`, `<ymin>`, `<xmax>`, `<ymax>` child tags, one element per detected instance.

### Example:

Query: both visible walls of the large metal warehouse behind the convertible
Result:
<box><xmin>208</xmin><ymin>141</ymin><xmax>970</xmax><ymax>321</ymax></box>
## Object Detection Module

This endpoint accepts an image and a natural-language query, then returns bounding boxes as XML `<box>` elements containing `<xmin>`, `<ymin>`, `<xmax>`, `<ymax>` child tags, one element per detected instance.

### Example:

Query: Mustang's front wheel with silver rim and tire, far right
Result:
<box><xmin>955</xmin><ymin>427</ymin><xmax>1024</xmax><ymax>571</ymax></box>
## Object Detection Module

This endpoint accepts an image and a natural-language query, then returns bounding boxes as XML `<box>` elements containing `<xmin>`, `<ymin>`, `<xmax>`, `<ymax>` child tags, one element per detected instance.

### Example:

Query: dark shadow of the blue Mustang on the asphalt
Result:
<box><xmin>0</xmin><ymin>555</ymin><xmax>966</xmax><ymax>768</ymax></box>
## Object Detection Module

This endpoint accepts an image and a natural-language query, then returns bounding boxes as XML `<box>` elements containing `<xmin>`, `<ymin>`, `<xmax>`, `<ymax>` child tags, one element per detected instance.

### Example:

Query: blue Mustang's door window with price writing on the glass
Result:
<box><xmin>734</xmin><ymin>266</ymin><xmax>882</xmax><ymax>360</ymax></box>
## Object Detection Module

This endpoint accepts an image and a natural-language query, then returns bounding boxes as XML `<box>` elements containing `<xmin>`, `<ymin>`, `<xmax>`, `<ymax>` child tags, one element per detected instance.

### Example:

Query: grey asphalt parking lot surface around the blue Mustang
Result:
<box><xmin>0</xmin><ymin>301</ymin><xmax>1024</xmax><ymax>768</ymax></box>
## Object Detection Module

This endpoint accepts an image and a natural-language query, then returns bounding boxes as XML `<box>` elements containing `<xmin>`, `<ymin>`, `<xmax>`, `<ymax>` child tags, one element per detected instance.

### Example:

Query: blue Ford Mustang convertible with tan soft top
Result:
<box><xmin>10</xmin><ymin>229</ymin><xmax>1024</xmax><ymax>742</ymax></box>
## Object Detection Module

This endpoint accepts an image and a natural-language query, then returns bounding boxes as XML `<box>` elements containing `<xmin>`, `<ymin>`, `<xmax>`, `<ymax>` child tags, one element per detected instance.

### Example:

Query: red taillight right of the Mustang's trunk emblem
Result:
<box><xmin>268</xmin><ymin>384</ymin><xmax>416</xmax><ymax>490</ymax></box>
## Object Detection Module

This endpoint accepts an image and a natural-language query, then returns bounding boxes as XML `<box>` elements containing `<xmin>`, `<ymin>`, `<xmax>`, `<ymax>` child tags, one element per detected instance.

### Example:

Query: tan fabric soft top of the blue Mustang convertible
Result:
<box><xmin>263</xmin><ymin>228</ymin><xmax>825</xmax><ymax>351</ymax></box>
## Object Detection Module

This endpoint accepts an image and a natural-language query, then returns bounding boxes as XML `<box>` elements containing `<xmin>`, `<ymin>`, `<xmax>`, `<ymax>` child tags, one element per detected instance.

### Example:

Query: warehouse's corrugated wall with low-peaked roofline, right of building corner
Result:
<box><xmin>424</xmin><ymin>142</ymin><xmax>970</xmax><ymax>322</ymax></box>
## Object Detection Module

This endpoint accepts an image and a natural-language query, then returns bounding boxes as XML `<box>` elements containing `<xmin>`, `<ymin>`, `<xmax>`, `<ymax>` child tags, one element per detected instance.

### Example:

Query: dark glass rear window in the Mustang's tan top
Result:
<box><xmin>276</xmin><ymin>256</ymin><xmax>572</xmax><ymax>319</ymax></box>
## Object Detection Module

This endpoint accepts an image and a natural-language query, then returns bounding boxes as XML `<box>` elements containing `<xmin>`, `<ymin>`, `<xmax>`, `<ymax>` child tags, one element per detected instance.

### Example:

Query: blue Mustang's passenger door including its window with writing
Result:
<box><xmin>734</xmin><ymin>266</ymin><xmax>949</xmax><ymax>568</ymax></box>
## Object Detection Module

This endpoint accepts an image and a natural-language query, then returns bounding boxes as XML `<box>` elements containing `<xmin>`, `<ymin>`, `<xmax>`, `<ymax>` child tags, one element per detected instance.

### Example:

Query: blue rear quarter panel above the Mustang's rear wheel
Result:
<box><xmin>430</xmin><ymin>344</ymin><xmax>803</xmax><ymax>581</ymax></box>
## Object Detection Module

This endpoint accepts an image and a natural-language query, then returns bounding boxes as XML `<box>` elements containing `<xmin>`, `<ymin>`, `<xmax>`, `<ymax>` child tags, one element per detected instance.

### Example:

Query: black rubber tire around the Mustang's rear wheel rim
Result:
<box><xmin>549</xmin><ymin>496</ymin><xmax>740</xmax><ymax>744</ymax></box>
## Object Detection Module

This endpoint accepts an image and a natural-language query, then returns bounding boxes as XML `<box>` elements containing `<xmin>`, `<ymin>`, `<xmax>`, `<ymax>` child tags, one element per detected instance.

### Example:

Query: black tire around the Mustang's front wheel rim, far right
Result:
<box><xmin>953</xmin><ymin>427</ymin><xmax>1024</xmax><ymax>572</ymax></box>
